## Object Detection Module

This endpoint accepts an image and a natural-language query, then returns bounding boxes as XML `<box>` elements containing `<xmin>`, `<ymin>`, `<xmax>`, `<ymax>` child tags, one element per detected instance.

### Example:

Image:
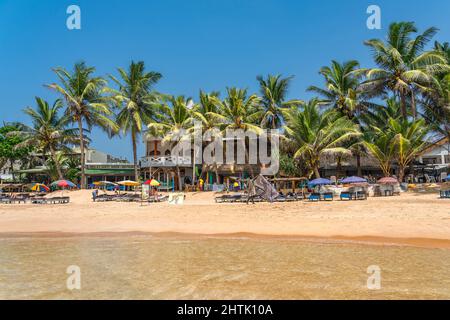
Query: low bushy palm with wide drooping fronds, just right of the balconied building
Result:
<box><xmin>284</xmin><ymin>99</ymin><xmax>361</xmax><ymax>178</ymax></box>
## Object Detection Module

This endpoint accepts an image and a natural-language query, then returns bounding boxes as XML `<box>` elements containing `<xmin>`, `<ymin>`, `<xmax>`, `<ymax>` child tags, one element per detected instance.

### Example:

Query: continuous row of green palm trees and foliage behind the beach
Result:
<box><xmin>0</xmin><ymin>22</ymin><xmax>450</xmax><ymax>187</ymax></box>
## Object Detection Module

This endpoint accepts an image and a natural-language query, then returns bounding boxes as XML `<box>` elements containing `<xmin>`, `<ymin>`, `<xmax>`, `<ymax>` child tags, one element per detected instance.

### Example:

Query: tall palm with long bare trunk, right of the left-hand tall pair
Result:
<box><xmin>107</xmin><ymin>61</ymin><xmax>162</xmax><ymax>180</ymax></box>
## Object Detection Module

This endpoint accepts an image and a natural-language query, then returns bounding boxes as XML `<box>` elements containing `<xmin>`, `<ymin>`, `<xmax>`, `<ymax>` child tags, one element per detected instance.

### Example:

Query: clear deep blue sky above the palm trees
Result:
<box><xmin>0</xmin><ymin>0</ymin><xmax>450</xmax><ymax>159</ymax></box>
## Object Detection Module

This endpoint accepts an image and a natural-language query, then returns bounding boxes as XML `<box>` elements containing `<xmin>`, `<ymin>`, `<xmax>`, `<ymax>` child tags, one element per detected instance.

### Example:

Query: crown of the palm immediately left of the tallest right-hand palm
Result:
<box><xmin>308</xmin><ymin>60</ymin><xmax>374</xmax><ymax>119</ymax></box>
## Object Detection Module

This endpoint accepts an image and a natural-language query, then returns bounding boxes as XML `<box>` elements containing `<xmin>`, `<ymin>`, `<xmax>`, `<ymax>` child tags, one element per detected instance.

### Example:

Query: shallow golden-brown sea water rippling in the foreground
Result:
<box><xmin>0</xmin><ymin>235</ymin><xmax>450</xmax><ymax>299</ymax></box>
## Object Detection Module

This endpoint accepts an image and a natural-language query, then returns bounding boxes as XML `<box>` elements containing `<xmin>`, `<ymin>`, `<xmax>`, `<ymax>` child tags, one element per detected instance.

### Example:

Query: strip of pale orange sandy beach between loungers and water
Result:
<box><xmin>0</xmin><ymin>191</ymin><xmax>450</xmax><ymax>248</ymax></box>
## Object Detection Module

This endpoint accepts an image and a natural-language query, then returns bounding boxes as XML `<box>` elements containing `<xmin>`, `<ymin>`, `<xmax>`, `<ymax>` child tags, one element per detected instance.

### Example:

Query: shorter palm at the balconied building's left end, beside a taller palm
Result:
<box><xmin>148</xmin><ymin>96</ymin><xmax>192</xmax><ymax>190</ymax></box>
